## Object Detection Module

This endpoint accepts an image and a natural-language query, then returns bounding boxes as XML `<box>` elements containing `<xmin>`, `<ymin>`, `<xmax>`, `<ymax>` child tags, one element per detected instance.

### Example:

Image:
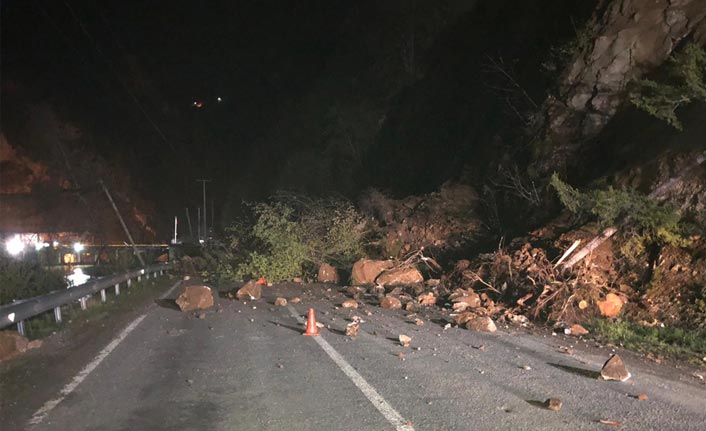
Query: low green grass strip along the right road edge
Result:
<box><xmin>588</xmin><ymin>319</ymin><xmax>706</xmax><ymax>358</ymax></box>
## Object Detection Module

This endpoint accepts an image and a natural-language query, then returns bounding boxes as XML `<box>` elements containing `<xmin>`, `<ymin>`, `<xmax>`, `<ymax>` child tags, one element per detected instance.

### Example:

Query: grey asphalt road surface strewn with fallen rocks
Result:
<box><xmin>1</xmin><ymin>285</ymin><xmax>706</xmax><ymax>431</ymax></box>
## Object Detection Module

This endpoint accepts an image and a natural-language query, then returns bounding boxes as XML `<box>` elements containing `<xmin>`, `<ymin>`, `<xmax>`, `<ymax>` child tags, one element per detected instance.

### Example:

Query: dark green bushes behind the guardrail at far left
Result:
<box><xmin>0</xmin><ymin>255</ymin><xmax>66</xmax><ymax>304</ymax></box>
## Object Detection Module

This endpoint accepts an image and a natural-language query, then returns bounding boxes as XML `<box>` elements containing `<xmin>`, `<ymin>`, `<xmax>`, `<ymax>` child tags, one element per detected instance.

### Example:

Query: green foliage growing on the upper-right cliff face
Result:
<box><xmin>629</xmin><ymin>43</ymin><xmax>706</xmax><ymax>130</ymax></box>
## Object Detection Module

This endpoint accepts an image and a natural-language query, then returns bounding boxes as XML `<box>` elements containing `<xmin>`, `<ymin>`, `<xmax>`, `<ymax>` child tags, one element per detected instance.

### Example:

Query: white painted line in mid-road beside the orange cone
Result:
<box><xmin>287</xmin><ymin>305</ymin><xmax>414</xmax><ymax>431</ymax></box>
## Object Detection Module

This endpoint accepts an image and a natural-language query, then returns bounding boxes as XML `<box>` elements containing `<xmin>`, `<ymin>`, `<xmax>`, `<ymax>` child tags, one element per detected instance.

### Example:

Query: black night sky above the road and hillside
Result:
<box><xmin>2</xmin><ymin>0</ymin><xmax>594</xmax><ymax>236</ymax></box>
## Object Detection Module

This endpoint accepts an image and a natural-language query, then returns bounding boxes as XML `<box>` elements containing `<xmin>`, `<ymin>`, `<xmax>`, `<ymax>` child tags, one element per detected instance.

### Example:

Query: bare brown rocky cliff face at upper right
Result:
<box><xmin>539</xmin><ymin>0</ymin><xmax>706</xmax><ymax>172</ymax></box>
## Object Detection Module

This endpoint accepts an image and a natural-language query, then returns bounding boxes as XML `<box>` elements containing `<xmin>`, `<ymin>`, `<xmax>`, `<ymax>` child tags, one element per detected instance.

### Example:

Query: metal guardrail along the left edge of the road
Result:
<box><xmin>0</xmin><ymin>264</ymin><xmax>171</xmax><ymax>335</ymax></box>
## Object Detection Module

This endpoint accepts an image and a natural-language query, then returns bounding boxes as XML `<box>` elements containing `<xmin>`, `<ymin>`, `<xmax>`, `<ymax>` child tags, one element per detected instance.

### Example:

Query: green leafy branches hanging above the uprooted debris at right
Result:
<box><xmin>551</xmin><ymin>173</ymin><xmax>689</xmax><ymax>260</ymax></box>
